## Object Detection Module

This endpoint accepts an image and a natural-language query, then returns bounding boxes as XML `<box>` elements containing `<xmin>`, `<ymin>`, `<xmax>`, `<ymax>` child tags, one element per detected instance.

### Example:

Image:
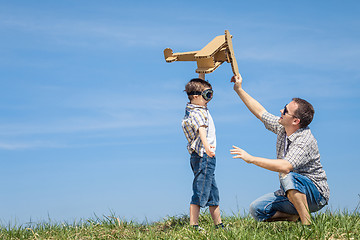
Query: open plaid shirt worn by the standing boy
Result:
<box><xmin>181</xmin><ymin>103</ymin><xmax>209</xmax><ymax>157</ymax></box>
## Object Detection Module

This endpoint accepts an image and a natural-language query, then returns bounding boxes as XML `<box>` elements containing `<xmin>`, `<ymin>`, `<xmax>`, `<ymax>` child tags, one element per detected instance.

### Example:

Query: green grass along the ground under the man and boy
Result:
<box><xmin>0</xmin><ymin>211</ymin><xmax>360</xmax><ymax>240</ymax></box>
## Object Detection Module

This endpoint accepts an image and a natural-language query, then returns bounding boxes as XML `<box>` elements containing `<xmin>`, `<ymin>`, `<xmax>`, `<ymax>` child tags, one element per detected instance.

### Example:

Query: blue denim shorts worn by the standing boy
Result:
<box><xmin>190</xmin><ymin>152</ymin><xmax>219</xmax><ymax>207</ymax></box>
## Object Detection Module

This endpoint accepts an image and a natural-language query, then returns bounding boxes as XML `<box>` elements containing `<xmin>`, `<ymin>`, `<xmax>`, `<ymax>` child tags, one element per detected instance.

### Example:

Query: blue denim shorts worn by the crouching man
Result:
<box><xmin>250</xmin><ymin>172</ymin><xmax>327</xmax><ymax>221</ymax></box>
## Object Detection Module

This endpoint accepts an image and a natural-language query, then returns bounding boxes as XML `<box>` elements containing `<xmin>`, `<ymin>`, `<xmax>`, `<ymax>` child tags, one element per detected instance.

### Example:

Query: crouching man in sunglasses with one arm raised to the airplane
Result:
<box><xmin>230</xmin><ymin>76</ymin><xmax>330</xmax><ymax>225</ymax></box>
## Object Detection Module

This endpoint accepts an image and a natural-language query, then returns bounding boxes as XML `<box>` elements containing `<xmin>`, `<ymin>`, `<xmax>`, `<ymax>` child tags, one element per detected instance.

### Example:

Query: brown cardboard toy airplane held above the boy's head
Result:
<box><xmin>164</xmin><ymin>30</ymin><xmax>240</xmax><ymax>79</ymax></box>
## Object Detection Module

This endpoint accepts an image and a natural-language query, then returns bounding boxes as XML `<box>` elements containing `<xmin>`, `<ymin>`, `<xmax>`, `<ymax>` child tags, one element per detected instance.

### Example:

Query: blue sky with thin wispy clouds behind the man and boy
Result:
<box><xmin>0</xmin><ymin>0</ymin><xmax>360</xmax><ymax>225</ymax></box>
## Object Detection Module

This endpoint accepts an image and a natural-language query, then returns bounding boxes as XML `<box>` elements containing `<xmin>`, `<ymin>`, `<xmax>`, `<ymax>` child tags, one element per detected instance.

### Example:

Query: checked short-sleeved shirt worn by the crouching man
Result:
<box><xmin>262</xmin><ymin>112</ymin><xmax>330</xmax><ymax>202</ymax></box>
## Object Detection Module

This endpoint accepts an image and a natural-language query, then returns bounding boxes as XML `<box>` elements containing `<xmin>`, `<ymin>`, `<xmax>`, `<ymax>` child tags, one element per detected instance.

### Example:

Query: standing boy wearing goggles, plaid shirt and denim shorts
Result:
<box><xmin>182</xmin><ymin>78</ymin><xmax>224</xmax><ymax>229</ymax></box>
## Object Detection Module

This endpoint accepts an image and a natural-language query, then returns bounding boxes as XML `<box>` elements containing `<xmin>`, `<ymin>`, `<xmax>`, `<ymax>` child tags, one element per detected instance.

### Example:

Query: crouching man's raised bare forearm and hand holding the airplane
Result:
<box><xmin>231</xmin><ymin>76</ymin><xmax>266</xmax><ymax>121</ymax></box>
